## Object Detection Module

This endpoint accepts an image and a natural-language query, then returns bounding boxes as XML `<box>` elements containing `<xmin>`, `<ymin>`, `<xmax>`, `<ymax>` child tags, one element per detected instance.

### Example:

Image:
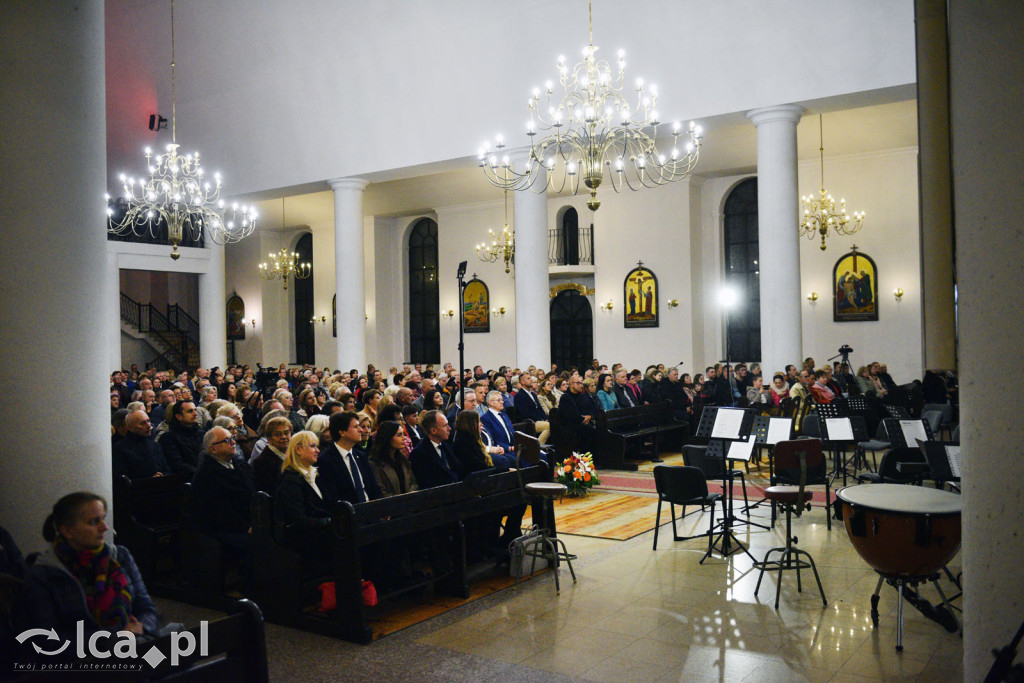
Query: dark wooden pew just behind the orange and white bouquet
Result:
<box><xmin>594</xmin><ymin>401</ymin><xmax>686</xmax><ymax>470</ymax></box>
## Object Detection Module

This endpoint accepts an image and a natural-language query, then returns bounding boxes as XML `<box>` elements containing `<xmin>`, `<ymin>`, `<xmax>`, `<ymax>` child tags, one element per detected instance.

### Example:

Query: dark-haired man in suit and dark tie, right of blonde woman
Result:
<box><xmin>316</xmin><ymin>411</ymin><xmax>382</xmax><ymax>507</ymax></box>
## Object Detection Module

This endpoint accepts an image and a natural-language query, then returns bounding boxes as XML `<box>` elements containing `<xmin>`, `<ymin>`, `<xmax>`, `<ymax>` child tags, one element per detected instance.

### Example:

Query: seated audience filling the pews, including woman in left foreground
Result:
<box><xmin>0</xmin><ymin>358</ymin><xmax>956</xmax><ymax>663</ymax></box>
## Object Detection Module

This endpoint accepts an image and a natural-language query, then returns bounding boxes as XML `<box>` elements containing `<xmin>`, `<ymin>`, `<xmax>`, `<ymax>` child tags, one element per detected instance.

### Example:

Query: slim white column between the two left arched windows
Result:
<box><xmin>328</xmin><ymin>178</ymin><xmax>370</xmax><ymax>372</ymax></box>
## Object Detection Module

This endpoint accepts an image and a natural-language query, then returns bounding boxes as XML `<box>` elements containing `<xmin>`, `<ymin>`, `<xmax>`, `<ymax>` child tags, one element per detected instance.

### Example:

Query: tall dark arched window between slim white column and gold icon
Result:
<box><xmin>409</xmin><ymin>218</ymin><xmax>441</xmax><ymax>362</ymax></box>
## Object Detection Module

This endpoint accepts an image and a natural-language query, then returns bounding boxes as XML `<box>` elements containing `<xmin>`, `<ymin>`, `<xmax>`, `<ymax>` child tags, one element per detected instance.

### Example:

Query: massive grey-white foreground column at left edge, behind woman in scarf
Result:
<box><xmin>0</xmin><ymin>0</ymin><xmax>111</xmax><ymax>553</ymax></box>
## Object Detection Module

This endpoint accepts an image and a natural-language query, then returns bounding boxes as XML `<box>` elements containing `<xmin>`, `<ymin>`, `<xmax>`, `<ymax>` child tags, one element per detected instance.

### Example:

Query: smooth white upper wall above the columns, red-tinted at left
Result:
<box><xmin>106</xmin><ymin>0</ymin><xmax>914</xmax><ymax>194</ymax></box>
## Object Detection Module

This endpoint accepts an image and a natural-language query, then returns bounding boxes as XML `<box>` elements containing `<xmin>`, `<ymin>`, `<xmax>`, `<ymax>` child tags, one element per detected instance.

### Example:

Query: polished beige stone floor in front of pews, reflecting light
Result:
<box><xmin>160</xmin><ymin>497</ymin><xmax>962</xmax><ymax>682</ymax></box>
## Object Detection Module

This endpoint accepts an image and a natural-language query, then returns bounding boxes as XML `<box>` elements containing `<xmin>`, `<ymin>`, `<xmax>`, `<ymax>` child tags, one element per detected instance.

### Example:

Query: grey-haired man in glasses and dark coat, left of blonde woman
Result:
<box><xmin>191</xmin><ymin>427</ymin><xmax>253</xmax><ymax>557</ymax></box>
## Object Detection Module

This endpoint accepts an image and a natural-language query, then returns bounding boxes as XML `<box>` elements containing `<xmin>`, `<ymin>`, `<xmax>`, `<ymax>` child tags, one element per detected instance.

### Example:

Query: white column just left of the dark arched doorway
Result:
<box><xmin>513</xmin><ymin>171</ymin><xmax>551</xmax><ymax>369</ymax></box>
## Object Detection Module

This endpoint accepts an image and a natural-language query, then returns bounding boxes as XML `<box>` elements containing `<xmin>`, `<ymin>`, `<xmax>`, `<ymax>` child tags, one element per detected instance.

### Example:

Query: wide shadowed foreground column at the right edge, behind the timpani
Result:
<box><xmin>946</xmin><ymin>0</ymin><xmax>1024</xmax><ymax>681</ymax></box>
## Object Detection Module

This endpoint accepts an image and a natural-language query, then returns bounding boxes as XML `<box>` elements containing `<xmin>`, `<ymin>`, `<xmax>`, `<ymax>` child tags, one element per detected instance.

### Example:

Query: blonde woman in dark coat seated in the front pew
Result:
<box><xmin>273</xmin><ymin>431</ymin><xmax>332</xmax><ymax>573</ymax></box>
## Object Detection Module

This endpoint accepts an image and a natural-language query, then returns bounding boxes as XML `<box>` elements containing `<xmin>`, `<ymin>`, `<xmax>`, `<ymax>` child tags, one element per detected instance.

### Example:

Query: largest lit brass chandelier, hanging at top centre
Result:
<box><xmin>478</xmin><ymin>3</ymin><xmax>701</xmax><ymax>211</ymax></box>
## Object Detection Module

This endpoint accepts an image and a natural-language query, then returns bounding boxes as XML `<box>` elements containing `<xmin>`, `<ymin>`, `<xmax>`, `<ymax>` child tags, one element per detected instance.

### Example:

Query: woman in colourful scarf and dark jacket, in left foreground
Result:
<box><xmin>19</xmin><ymin>492</ymin><xmax>159</xmax><ymax>642</ymax></box>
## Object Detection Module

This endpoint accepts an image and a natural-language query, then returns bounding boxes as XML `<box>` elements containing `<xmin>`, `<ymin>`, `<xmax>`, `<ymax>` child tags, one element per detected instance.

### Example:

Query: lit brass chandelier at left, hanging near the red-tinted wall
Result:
<box><xmin>106</xmin><ymin>0</ymin><xmax>257</xmax><ymax>259</ymax></box>
